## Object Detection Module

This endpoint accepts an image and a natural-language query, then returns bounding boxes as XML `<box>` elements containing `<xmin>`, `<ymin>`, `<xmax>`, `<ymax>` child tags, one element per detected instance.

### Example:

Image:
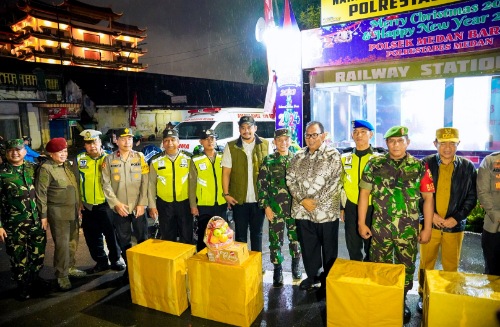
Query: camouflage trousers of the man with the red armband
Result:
<box><xmin>370</xmin><ymin>219</ymin><xmax>418</xmax><ymax>296</ymax></box>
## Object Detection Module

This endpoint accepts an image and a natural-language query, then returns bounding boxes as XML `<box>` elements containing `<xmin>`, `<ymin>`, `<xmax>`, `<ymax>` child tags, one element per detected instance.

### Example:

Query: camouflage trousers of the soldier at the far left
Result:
<box><xmin>5</xmin><ymin>221</ymin><xmax>47</xmax><ymax>283</ymax></box>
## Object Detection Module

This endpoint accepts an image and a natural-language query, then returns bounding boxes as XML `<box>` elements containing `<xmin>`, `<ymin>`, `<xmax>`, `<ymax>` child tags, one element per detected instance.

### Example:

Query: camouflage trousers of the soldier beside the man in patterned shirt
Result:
<box><xmin>269</xmin><ymin>216</ymin><xmax>301</xmax><ymax>265</ymax></box>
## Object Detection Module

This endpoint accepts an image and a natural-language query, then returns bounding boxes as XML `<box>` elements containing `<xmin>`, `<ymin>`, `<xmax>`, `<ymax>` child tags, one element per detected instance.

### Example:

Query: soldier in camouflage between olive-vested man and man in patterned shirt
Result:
<box><xmin>257</xmin><ymin>128</ymin><xmax>302</xmax><ymax>287</ymax></box>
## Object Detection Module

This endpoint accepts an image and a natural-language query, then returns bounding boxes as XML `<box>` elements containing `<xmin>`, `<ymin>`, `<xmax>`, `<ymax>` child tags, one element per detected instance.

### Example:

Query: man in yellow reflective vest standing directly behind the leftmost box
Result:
<box><xmin>148</xmin><ymin>129</ymin><xmax>193</xmax><ymax>244</ymax></box>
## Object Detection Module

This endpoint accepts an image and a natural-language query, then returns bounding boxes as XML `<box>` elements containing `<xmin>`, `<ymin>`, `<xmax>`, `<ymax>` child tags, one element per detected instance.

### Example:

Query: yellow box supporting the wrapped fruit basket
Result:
<box><xmin>187</xmin><ymin>249</ymin><xmax>264</xmax><ymax>326</ymax></box>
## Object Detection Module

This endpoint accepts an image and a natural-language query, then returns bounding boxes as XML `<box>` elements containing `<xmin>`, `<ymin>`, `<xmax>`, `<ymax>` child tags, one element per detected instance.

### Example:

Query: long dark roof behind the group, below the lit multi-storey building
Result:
<box><xmin>0</xmin><ymin>57</ymin><xmax>266</xmax><ymax>109</ymax></box>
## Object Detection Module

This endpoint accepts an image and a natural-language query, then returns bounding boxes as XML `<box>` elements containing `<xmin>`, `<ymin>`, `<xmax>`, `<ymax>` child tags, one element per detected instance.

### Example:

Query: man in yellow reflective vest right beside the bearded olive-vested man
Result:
<box><xmin>189</xmin><ymin>129</ymin><xmax>227</xmax><ymax>251</ymax></box>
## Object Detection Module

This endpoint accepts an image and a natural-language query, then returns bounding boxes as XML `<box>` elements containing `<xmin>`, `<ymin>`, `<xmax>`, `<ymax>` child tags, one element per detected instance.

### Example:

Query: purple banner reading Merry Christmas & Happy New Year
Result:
<box><xmin>302</xmin><ymin>0</ymin><xmax>500</xmax><ymax>69</ymax></box>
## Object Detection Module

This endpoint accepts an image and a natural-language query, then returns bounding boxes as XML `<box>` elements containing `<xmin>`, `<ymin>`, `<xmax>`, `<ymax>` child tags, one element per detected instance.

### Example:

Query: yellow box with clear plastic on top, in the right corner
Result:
<box><xmin>422</xmin><ymin>270</ymin><xmax>500</xmax><ymax>327</ymax></box>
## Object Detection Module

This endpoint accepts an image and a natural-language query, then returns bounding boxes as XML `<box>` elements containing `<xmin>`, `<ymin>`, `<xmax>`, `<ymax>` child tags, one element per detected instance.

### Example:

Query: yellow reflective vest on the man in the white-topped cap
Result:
<box><xmin>76</xmin><ymin>152</ymin><xmax>107</xmax><ymax>205</ymax></box>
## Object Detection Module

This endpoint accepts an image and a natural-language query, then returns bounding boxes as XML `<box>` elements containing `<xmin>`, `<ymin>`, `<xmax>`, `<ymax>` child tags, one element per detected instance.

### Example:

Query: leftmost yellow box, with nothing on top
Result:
<box><xmin>127</xmin><ymin>239</ymin><xmax>196</xmax><ymax>316</ymax></box>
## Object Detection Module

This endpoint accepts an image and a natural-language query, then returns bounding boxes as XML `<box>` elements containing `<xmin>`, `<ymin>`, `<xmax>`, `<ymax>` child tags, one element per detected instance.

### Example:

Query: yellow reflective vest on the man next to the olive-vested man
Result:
<box><xmin>193</xmin><ymin>152</ymin><xmax>226</xmax><ymax>206</ymax></box>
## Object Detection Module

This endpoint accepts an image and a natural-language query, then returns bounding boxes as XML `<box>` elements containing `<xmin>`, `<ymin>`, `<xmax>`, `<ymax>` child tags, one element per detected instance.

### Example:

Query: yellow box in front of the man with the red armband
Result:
<box><xmin>326</xmin><ymin>258</ymin><xmax>405</xmax><ymax>327</ymax></box>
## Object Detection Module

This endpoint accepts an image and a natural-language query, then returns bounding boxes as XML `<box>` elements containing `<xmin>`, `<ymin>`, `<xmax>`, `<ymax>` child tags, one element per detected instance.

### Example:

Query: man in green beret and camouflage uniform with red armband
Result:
<box><xmin>358</xmin><ymin>126</ymin><xmax>434</xmax><ymax>322</ymax></box>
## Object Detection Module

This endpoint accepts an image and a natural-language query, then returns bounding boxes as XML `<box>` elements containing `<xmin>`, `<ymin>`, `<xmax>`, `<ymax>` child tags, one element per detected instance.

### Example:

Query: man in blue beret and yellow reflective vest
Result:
<box><xmin>340</xmin><ymin>119</ymin><xmax>384</xmax><ymax>261</ymax></box>
